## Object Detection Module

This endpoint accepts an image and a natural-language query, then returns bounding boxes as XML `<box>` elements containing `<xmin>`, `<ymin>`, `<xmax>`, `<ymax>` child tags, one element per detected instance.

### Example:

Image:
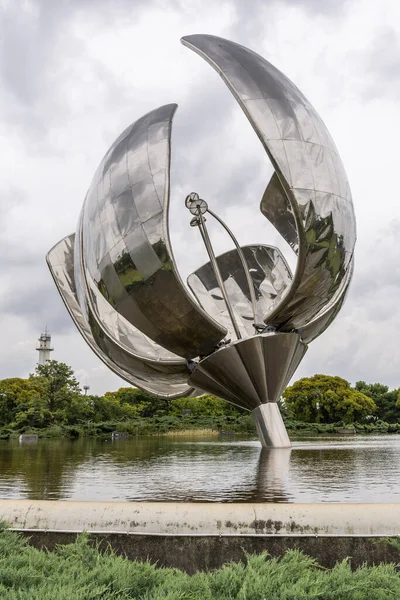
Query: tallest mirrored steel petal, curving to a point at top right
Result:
<box><xmin>182</xmin><ymin>35</ymin><xmax>356</xmax><ymax>331</ymax></box>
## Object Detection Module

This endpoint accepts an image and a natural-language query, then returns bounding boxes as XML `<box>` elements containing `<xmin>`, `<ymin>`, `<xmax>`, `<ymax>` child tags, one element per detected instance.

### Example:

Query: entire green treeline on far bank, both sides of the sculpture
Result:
<box><xmin>0</xmin><ymin>360</ymin><xmax>400</xmax><ymax>437</ymax></box>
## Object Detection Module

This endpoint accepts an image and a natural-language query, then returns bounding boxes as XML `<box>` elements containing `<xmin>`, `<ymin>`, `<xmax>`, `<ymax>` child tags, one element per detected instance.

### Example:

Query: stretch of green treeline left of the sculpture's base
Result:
<box><xmin>0</xmin><ymin>360</ymin><xmax>253</xmax><ymax>437</ymax></box>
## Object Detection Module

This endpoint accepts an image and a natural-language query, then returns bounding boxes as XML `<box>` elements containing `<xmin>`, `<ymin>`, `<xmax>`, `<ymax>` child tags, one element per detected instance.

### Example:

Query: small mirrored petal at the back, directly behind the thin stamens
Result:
<box><xmin>187</xmin><ymin>245</ymin><xmax>292</xmax><ymax>337</ymax></box>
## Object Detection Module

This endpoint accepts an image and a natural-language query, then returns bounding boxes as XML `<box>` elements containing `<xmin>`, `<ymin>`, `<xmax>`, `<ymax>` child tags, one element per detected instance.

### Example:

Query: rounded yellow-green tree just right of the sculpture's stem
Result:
<box><xmin>283</xmin><ymin>375</ymin><xmax>376</xmax><ymax>423</ymax></box>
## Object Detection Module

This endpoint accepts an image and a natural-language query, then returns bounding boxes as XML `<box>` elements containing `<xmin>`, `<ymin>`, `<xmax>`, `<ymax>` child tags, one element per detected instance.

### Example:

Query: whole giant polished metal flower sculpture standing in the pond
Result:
<box><xmin>47</xmin><ymin>35</ymin><xmax>356</xmax><ymax>447</ymax></box>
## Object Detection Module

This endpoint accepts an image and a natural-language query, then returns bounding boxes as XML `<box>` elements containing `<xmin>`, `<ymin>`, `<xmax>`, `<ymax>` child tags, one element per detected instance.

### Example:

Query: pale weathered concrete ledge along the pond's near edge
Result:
<box><xmin>0</xmin><ymin>500</ymin><xmax>400</xmax><ymax>538</ymax></box>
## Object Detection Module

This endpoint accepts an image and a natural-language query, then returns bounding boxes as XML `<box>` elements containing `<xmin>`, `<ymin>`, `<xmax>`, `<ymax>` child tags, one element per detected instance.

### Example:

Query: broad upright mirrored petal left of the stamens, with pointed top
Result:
<box><xmin>76</xmin><ymin>104</ymin><xmax>226</xmax><ymax>358</ymax></box>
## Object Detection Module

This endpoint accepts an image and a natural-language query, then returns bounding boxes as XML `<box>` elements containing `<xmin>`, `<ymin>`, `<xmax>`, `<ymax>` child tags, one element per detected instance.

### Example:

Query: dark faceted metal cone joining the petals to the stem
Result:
<box><xmin>188</xmin><ymin>333</ymin><xmax>307</xmax><ymax>410</ymax></box>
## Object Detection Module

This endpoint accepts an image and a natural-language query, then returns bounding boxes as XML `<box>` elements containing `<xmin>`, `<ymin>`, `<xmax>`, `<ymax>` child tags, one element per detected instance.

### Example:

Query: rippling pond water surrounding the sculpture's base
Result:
<box><xmin>0</xmin><ymin>435</ymin><xmax>400</xmax><ymax>502</ymax></box>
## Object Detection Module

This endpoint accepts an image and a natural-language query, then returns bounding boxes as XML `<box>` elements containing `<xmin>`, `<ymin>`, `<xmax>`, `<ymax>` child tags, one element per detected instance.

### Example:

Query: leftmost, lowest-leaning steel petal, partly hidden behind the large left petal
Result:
<box><xmin>46</xmin><ymin>234</ymin><xmax>194</xmax><ymax>398</ymax></box>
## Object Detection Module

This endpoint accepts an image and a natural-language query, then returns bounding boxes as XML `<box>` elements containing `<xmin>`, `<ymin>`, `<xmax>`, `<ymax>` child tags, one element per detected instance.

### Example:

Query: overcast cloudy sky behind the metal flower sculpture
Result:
<box><xmin>0</xmin><ymin>0</ymin><xmax>400</xmax><ymax>394</ymax></box>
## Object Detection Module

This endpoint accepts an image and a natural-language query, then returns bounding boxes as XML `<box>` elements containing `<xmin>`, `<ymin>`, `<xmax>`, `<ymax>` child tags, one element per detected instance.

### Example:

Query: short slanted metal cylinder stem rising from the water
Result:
<box><xmin>251</xmin><ymin>402</ymin><xmax>291</xmax><ymax>448</ymax></box>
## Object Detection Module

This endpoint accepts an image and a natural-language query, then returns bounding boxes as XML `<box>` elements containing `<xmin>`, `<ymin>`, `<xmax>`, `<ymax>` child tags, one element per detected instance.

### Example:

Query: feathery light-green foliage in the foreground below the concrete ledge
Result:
<box><xmin>0</xmin><ymin>530</ymin><xmax>400</xmax><ymax>600</ymax></box>
